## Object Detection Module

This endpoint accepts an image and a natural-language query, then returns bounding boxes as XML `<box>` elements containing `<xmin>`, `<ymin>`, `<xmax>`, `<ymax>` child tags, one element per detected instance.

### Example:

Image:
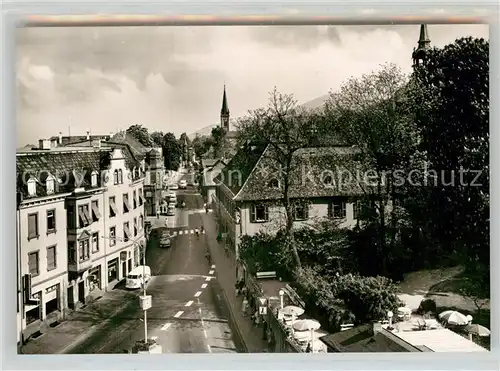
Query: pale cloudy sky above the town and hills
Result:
<box><xmin>17</xmin><ymin>25</ymin><xmax>488</xmax><ymax>145</ymax></box>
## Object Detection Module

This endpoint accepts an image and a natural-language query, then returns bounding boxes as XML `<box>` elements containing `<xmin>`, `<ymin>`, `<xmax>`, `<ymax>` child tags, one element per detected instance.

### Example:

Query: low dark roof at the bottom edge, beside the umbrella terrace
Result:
<box><xmin>320</xmin><ymin>324</ymin><xmax>422</xmax><ymax>353</ymax></box>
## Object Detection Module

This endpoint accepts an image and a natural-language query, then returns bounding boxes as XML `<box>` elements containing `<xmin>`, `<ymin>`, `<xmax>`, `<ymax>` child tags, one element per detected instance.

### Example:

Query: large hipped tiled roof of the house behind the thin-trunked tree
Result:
<box><xmin>216</xmin><ymin>145</ymin><xmax>363</xmax><ymax>201</ymax></box>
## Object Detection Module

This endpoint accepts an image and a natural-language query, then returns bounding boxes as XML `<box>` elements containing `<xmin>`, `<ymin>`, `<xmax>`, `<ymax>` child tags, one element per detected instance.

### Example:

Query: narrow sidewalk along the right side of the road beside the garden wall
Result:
<box><xmin>202</xmin><ymin>213</ymin><xmax>268</xmax><ymax>353</ymax></box>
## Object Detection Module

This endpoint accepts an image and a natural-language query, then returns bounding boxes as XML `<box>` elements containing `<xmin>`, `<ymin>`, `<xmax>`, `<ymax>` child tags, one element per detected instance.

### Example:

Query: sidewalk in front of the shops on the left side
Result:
<box><xmin>20</xmin><ymin>292</ymin><xmax>135</xmax><ymax>354</ymax></box>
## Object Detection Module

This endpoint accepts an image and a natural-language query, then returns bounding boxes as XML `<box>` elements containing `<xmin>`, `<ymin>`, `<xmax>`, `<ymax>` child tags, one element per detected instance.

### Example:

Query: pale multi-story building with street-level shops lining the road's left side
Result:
<box><xmin>16</xmin><ymin>146</ymin><xmax>144</xmax><ymax>338</ymax></box>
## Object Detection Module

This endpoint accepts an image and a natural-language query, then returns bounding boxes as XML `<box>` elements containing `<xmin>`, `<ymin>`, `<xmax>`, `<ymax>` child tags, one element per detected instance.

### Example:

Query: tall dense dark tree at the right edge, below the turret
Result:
<box><xmin>414</xmin><ymin>37</ymin><xmax>490</xmax><ymax>282</ymax></box>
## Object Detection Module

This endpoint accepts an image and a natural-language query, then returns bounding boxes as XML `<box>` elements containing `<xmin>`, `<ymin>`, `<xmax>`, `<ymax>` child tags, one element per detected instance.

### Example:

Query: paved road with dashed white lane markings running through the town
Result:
<box><xmin>67</xmin><ymin>176</ymin><xmax>240</xmax><ymax>354</ymax></box>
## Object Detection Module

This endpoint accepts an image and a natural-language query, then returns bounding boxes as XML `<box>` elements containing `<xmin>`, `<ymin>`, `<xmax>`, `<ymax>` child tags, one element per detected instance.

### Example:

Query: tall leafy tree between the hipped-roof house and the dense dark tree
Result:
<box><xmin>325</xmin><ymin>65</ymin><xmax>418</xmax><ymax>275</ymax></box>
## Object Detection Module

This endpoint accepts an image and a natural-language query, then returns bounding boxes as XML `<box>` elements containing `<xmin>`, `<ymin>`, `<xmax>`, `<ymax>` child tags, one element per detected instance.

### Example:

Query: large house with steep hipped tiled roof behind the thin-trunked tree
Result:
<box><xmin>212</xmin><ymin>145</ymin><xmax>362</xmax><ymax>260</ymax></box>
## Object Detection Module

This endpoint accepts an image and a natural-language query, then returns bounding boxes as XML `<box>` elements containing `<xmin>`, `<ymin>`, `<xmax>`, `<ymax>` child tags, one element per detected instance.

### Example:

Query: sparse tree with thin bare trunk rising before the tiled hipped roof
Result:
<box><xmin>237</xmin><ymin>88</ymin><xmax>324</xmax><ymax>269</ymax></box>
